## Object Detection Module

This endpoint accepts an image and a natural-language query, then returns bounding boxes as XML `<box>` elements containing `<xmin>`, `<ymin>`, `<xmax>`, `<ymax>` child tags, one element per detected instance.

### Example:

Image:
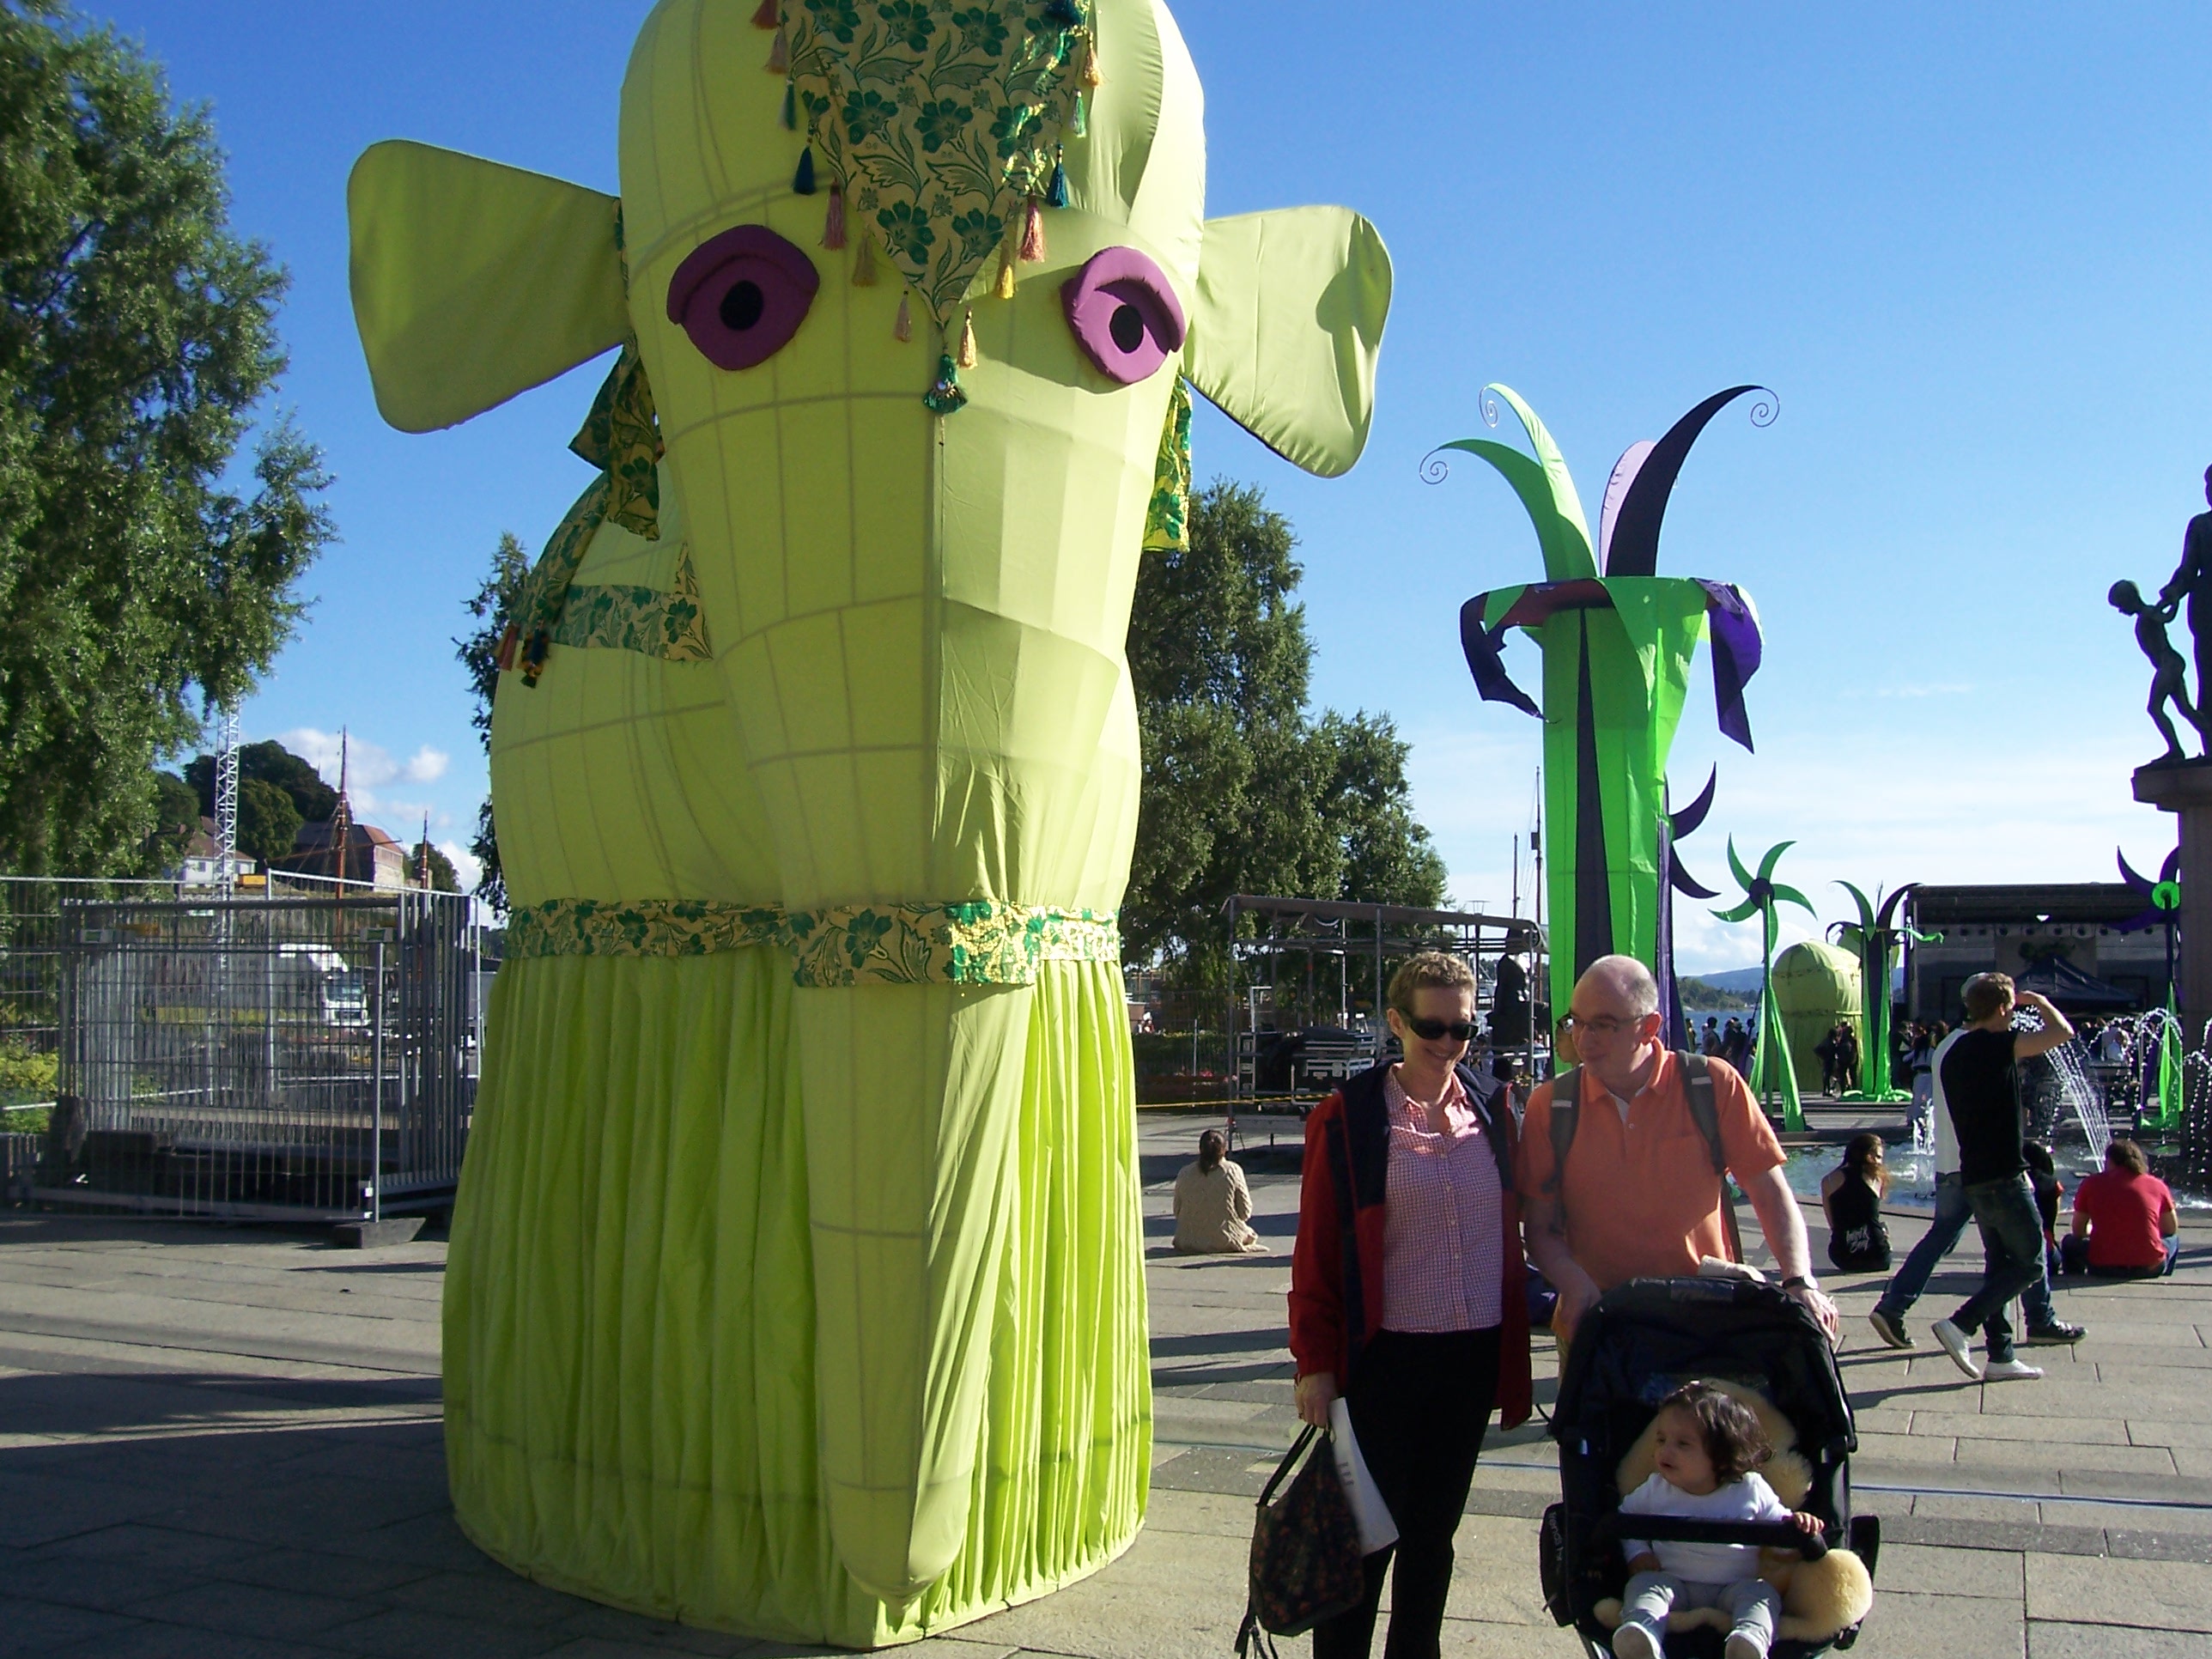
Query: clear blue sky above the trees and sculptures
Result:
<box><xmin>88</xmin><ymin>0</ymin><xmax>2212</xmax><ymax>971</ymax></box>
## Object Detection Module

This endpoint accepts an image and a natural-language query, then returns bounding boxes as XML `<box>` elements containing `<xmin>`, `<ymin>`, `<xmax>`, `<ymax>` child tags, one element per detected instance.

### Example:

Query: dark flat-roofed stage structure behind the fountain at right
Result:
<box><xmin>1905</xmin><ymin>880</ymin><xmax>2167</xmax><ymax>1024</ymax></box>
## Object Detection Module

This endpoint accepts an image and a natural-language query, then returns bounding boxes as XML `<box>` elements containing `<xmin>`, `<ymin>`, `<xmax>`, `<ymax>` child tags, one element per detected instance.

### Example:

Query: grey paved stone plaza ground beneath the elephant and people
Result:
<box><xmin>0</xmin><ymin>1113</ymin><xmax>2212</xmax><ymax>1659</ymax></box>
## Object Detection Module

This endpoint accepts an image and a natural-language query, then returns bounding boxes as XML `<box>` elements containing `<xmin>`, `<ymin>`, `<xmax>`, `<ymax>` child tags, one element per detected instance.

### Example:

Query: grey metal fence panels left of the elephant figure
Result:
<box><xmin>0</xmin><ymin>883</ymin><xmax>483</xmax><ymax>1218</ymax></box>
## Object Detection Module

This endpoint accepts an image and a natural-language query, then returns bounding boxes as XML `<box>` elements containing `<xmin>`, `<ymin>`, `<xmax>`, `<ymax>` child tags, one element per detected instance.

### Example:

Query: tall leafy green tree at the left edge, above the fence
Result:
<box><xmin>0</xmin><ymin>0</ymin><xmax>331</xmax><ymax>874</ymax></box>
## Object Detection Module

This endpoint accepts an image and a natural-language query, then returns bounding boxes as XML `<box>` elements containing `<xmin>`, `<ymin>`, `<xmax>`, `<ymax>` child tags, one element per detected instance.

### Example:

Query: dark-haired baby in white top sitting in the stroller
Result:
<box><xmin>1613</xmin><ymin>1382</ymin><xmax>1820</xmax><ymax>1659</ymax></box>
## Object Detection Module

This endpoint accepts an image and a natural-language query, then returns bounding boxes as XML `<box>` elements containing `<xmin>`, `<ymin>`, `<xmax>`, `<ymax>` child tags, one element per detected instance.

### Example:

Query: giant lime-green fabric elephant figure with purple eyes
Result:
<box><xmin>349</xmin><ymin>0</ymin><xmax>1389</xmax><ymax>1646</ymax></box>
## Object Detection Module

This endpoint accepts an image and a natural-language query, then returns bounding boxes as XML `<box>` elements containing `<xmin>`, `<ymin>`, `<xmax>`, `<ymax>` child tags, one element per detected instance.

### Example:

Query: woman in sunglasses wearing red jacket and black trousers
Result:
<box><xmin>1290</xmin><ymin>951</ymin><xmax>1528</xmax><ymax>1659</ymax></box>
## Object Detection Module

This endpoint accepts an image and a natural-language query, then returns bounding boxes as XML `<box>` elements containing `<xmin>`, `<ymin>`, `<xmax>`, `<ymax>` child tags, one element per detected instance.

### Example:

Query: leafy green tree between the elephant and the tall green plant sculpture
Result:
<box><xmin>1121</xmin><ymin>480</ymin><xmax>1444</xmax><ymax>982</ymax></box>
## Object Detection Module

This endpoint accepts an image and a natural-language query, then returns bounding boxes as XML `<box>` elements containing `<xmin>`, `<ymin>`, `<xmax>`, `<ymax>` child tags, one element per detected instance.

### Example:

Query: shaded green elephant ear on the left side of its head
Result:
<box><xmin>345</xmin><ymin>139</ymin><xmax>630</xmax><ymax>431</ymax></box>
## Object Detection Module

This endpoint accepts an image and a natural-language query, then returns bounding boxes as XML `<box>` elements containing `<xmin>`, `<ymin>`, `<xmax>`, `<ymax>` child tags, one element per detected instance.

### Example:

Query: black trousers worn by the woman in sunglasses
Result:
<box><xmin>1314</xmin><ymin>1329</ymin><xmax>1498</xmax><ymax>1659</ymax></box>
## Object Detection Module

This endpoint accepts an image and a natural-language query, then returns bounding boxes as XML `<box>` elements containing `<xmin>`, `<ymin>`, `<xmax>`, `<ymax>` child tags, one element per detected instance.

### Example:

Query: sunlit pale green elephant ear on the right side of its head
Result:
<box><xmin>1183</xmin><ymin>208</ymin><xmax>1389</xmax><ymax>477</ymax></box>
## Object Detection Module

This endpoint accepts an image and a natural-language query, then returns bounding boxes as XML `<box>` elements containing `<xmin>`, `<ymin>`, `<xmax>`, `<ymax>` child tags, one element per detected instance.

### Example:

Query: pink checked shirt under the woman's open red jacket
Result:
<box><xmin>1382</xmin><ymin>1071</ymin><xmax>1504</xmax><ymax>1332</ymax></box>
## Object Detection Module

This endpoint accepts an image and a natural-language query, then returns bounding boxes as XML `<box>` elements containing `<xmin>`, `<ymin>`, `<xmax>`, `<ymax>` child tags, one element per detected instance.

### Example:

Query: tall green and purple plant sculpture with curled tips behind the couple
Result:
<box><xmin>1422</xmin><ymin>385</ymin><xmax>1774</xmax><ymax>1046</ymax></box>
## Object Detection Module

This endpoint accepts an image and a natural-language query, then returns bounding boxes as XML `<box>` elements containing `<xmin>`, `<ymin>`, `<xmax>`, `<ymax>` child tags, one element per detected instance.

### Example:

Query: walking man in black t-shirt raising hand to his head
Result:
<box><xmin>1936</xmin><ymin>973</ymin><xmax>2073</xmax><ymax>1382</ymax></box>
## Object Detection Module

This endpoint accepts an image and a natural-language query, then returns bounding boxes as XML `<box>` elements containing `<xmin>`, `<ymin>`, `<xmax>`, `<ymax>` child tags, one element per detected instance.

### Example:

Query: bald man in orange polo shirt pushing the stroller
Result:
<box><xmin>1517</xmin><ymin>956</ymin><xmax>1836</xmax><ymax>1343</ymax></box>
